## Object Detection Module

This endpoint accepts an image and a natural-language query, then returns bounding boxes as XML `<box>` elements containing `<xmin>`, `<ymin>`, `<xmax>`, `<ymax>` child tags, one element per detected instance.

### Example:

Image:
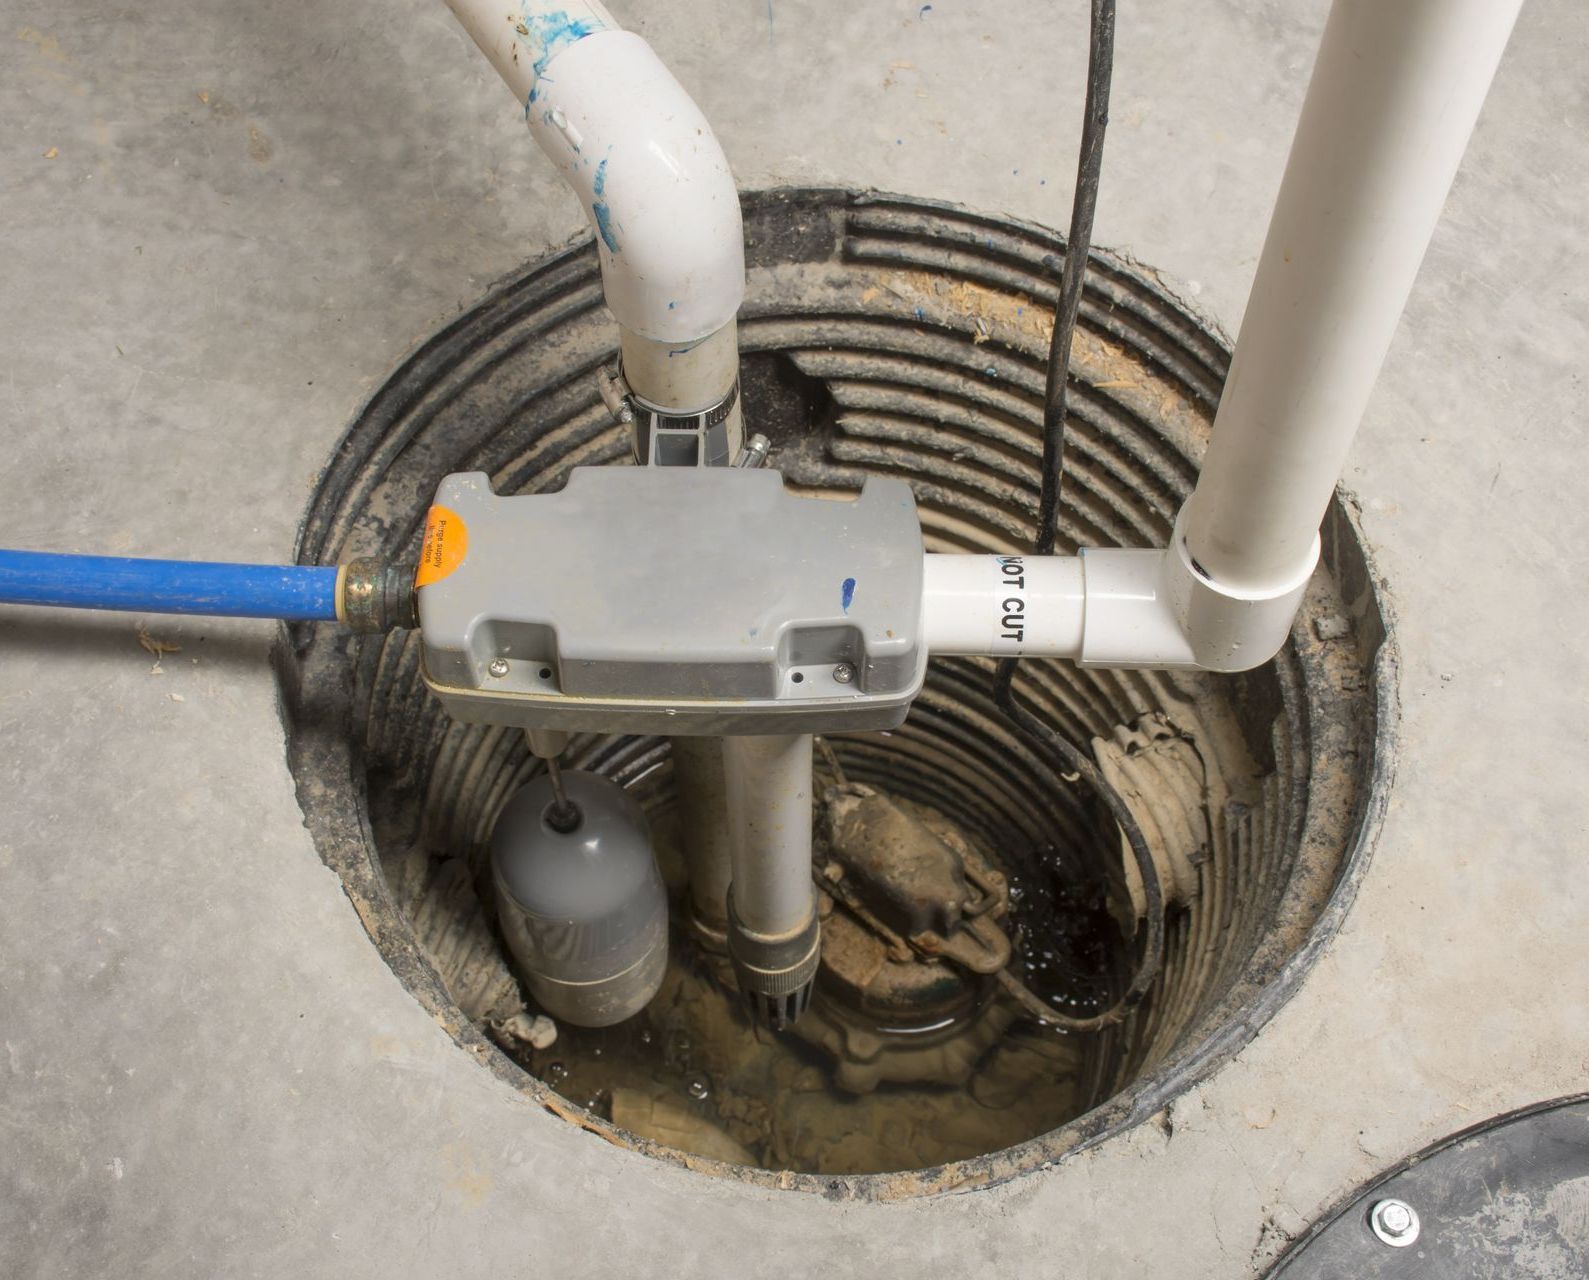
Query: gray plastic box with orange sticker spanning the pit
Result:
<box><xmin>418</xmin><ymin>467</ymin><xmax>926</xmax><ymax>735</ymax></box>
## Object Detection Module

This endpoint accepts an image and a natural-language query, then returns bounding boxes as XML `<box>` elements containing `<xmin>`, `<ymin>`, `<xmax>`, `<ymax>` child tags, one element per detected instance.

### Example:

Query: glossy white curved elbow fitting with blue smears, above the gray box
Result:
<box><xmin>526</xmin><ymin>30</ymin><xmax>745</xmax><ymax>346</ymax></box>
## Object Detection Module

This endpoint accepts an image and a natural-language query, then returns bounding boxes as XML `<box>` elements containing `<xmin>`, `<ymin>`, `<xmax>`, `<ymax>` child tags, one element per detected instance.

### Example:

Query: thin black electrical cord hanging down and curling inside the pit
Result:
<box><xmin>993</xmin><ymin>0</ymin><xmax>1165</xmax><ymax>1031</ymax></box>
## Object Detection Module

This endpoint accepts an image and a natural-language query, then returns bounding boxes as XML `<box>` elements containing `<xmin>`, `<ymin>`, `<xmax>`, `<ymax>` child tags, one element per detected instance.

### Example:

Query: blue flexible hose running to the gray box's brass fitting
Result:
<box><xmin>0</xmin><ymin>549</ymin><xmax>338</xmax><ymax>623</ymax></box>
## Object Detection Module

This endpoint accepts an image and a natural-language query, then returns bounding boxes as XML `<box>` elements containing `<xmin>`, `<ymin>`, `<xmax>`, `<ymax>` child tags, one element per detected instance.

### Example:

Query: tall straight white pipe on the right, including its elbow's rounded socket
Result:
<box><xmin>1165</xmin><ymin>0</ymin><xmax>1521</xmax><ymax>670</ymax></box>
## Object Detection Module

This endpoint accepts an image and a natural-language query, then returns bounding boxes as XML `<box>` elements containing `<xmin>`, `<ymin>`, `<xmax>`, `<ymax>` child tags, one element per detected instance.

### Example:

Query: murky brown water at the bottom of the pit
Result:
<box><xmin>492</xmin><ymin>797</ymin><xmax>1119</xmax><ymax>1175</ymax></box>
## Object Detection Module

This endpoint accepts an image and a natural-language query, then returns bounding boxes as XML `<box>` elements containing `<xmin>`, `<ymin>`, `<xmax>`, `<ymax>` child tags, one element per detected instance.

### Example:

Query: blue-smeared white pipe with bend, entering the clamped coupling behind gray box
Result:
<box><xmin>448</xmin><ymin>0</ymin><xmax>745</xmax><ymax>431</ymax></box>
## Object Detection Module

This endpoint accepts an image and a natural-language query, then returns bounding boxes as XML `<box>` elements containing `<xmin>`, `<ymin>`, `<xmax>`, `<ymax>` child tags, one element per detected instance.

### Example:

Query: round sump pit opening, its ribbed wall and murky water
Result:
<box><xmin>281</xmin><ymin>191</ymin><xmax>1389</xmax><ymax>1194</ymax></box>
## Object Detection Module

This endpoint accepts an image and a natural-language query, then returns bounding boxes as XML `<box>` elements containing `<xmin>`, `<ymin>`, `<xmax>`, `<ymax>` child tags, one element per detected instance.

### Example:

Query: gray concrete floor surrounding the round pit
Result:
<box><xmin>0</xmin><ymin>0</ymin><xmax>1589</xmax><ymax>1277</ymax></box>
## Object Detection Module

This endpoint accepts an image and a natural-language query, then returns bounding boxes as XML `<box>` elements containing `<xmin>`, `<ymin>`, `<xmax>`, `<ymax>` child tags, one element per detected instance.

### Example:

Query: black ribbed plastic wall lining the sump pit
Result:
<box><xmin>302</xmin><ymin>191</ymin><xmax>1367</xmax><ymax>1124</ymax></box>
